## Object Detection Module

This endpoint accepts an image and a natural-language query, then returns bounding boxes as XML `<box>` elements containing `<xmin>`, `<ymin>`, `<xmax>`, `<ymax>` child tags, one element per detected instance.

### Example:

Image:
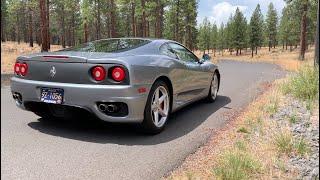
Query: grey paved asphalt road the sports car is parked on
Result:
<box><xmin>1</xmin><ymin>61</ymin><xmax>285</xmax><ymax>180</ymax></box>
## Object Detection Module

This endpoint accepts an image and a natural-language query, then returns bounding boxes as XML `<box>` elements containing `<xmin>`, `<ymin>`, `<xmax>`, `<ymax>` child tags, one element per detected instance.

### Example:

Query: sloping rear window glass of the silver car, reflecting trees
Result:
<box><xmin>61</xmin><ymin>39</ymin><xmax>150</xmax><ymax>53</ymax></box>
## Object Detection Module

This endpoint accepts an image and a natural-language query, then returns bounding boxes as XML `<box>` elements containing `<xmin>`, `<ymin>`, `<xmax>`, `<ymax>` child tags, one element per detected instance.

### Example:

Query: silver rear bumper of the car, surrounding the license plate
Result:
<box><xmin>11</xmin><ymin>77</ymin><xmax>151</xmax><ymax>123</ymax></box>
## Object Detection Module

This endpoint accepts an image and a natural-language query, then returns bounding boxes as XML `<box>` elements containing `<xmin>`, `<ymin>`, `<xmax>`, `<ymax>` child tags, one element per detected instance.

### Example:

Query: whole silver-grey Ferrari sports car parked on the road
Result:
<box><xmin>11</xmin><ymin>38</ymin><xmax>220</xmax><ymax>133</ymax></box>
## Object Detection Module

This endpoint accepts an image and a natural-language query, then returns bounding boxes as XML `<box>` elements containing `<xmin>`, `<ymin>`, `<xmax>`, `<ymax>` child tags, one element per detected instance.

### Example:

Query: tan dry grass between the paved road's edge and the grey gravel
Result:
<box><xmin>166</xmin><ymin>81</ymin><xmax>302</xmax><ymax>180</ymax></box>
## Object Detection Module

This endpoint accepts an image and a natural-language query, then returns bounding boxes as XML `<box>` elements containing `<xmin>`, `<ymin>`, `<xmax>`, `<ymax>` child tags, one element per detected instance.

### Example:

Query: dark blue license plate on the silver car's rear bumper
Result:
<box><xmin>40</xmin><ymin>88</ymin><xmax>64</xmax><ymax>104</ymax></box>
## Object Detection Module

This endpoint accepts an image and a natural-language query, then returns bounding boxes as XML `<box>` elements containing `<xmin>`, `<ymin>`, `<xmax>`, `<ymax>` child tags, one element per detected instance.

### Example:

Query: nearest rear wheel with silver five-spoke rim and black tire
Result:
<box><xmin>142</xmin><ymin>81</ymin><xmax>171</xmax><ymax>134</ymax></box>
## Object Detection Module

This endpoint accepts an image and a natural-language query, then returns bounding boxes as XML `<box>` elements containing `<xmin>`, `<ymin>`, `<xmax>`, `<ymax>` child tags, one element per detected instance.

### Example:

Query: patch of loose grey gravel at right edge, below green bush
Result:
<box><xmin>273</xmin><ymin>97</ymin><xmax>319</xmax><ymax>180</ymax></box>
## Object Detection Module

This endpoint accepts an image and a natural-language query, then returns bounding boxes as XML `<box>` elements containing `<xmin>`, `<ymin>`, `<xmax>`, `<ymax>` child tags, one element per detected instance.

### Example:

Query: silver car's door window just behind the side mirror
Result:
<box><xmin>169</xmin><ymin>43</ymin><xmax>199</xmax><ymax>63</ymax></box>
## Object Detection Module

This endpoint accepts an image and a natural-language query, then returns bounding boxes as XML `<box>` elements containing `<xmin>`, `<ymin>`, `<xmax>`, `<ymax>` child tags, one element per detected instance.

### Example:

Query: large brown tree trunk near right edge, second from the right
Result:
<box><xmin>299</xmin><ymin>1</ymin><xmax>308</xmax><ymax>60</ymax></box>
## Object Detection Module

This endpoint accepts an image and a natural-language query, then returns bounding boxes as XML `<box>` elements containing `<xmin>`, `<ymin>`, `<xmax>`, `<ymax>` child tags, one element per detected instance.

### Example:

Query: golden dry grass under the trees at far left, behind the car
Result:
<box><xmin>1</xmin><ymin>41</ymin><xmax>62</xmax><ymax>74</ymax></box>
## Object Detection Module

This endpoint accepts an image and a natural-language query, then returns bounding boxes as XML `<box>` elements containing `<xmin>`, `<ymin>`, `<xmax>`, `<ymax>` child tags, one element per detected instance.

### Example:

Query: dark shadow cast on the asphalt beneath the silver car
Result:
<box><xmin>28</xmin><ymin>96</ymin><xmax>231</xmax><ymax>145</ymax></box>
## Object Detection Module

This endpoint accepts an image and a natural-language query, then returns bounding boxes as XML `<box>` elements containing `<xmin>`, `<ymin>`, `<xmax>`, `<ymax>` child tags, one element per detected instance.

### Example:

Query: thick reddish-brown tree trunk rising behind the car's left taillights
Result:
<box><xmin>39</xmin><ymin>0</ymin><xmax>49</xmax><ymax>52</ymax></box>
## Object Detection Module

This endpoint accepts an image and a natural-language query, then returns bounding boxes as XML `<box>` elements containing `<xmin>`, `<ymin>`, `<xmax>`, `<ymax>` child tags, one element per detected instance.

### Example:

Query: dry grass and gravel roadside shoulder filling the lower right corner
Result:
<box><xmin>164</xmin><ymin>70</ymin><xmax>319</xmax><ymax>179</ymax></box>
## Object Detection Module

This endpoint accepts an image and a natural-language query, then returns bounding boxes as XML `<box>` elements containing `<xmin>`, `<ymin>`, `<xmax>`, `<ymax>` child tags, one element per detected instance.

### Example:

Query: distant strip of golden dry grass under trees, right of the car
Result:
<box><xmin>195</xmin><ymin>47</ymin><xmax>314</xmax><ymax>71</ymax></box>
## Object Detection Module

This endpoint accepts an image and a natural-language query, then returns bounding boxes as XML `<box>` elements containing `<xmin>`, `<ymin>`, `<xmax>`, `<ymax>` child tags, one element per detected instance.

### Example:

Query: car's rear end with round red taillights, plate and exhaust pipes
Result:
<box><xmin>11</xmin><ymin>52</ymin><xmax>147</xmax><ymax>122</ymax></box>
